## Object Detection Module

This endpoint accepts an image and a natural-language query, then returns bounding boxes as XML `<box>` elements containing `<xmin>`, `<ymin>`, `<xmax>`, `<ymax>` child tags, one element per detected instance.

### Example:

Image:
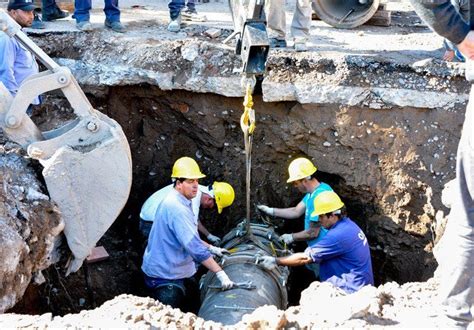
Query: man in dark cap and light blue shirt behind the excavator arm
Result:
<box><xmin>0</xmin><ymin>0</ymin><xmax>40</xmax><ymax>114</ymax></box>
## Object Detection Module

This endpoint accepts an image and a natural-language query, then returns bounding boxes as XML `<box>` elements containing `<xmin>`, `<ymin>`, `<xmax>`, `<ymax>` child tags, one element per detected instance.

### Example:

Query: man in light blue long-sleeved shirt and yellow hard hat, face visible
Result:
<box><xmin>142</xmin><ymin>157</ymin><xmax>234</xmax><ymax>308</ymax></box>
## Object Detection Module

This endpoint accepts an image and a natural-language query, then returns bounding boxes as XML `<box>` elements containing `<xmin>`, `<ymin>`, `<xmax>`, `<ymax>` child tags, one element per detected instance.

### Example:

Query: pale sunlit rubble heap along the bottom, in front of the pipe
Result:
<box><xmin>0</xmin><ymin>279</ymin><xmax>455</xmax><ymax>329</ymax></box>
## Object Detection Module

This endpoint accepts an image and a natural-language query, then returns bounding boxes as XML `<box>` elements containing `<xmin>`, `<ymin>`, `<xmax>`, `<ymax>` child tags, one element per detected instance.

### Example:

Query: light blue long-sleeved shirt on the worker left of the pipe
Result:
<box><xmin>142</xmin><ymin>189</ymin><xmax>211</xmax><ymax>280</ymax></box>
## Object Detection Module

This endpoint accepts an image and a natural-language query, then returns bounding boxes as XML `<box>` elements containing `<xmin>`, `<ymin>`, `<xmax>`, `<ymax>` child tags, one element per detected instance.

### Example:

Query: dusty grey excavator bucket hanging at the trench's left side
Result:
<box><xmin>28</xmin><ymin>111</ymin><xmax>132</xmax><ymax>274</ymax></box>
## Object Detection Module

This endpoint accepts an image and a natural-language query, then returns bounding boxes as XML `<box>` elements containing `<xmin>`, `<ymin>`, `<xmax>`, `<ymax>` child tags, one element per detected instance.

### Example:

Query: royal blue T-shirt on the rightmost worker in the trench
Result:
<box><xmin>305</xmin><ymin>217</ymin><xmax>374</xmax><ymax>293</ymax></box>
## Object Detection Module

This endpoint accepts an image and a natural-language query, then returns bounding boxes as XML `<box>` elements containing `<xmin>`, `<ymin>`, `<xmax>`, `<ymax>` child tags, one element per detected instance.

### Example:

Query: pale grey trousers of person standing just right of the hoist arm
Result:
<box><xmin>265</xmin><ymin>0</ymin><xmax>312</xmax><ymax>42</ymax></box>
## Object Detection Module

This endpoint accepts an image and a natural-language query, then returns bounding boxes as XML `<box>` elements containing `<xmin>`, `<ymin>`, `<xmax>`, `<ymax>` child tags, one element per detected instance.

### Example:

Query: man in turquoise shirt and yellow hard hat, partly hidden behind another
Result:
<box><xmin>257</xmin><ymin>157</ymin><xmax>332</xmax><ymax>277</ymax></box>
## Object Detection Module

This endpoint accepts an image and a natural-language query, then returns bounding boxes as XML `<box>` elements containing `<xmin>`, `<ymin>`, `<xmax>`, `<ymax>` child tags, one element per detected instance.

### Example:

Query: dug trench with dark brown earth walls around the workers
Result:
<box><xmin>10</xmin><ymin>84</ymin><xmax>448</xmax><ymax>315</ymax></box>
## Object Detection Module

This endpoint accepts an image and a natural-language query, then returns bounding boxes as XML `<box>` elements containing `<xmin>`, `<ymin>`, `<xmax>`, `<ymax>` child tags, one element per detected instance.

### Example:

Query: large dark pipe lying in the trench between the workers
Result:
<box><xmin>198</xmin><ymin>222</ymin><xmax>289</xmax><ymax>325</ymax></box>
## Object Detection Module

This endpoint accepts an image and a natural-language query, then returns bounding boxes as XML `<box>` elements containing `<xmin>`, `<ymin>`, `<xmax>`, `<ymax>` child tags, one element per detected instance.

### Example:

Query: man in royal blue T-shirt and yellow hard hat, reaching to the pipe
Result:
<box><xmin>258</xmin><ymin>191</ymin><xmax>374</xmax><ymax>293</ymax></box>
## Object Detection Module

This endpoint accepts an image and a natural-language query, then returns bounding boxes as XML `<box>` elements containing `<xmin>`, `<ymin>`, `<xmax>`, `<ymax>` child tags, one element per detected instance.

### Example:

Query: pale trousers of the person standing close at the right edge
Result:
<box><xmin>435</xmin><ymin>84</ymin><xmax>474</xmax><ymax>322</ymax></box>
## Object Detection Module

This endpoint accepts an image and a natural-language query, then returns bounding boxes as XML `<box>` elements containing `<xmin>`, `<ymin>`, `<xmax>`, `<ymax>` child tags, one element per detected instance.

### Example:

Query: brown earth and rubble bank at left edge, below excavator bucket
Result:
<box><xmin>0</xmin><ymin>143</ymin><xmax>64</xmax><ymax>312</ymax></box>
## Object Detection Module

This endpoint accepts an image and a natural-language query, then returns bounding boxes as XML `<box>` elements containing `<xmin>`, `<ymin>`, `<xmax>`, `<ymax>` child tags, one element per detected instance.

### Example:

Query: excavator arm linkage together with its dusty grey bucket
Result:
<box><xmin>0</xmin><ymin>10</ymin><xmax>132</xmax><ymax>274</ymax></box>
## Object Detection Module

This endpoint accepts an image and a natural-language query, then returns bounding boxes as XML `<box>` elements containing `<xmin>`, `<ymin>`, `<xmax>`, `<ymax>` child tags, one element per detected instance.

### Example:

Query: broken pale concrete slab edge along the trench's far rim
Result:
<box><xmin>57</xmin><ymin>56</ymin><xmax>469</xmax><ymax>109</ymax></box>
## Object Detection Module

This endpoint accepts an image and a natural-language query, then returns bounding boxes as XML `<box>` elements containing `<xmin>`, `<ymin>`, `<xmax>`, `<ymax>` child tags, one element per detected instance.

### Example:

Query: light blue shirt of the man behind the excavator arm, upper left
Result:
<box><xmin>0</xmin><ymin>32</ymin><xmax>40</xmax><ymax>104</ymax></box>
